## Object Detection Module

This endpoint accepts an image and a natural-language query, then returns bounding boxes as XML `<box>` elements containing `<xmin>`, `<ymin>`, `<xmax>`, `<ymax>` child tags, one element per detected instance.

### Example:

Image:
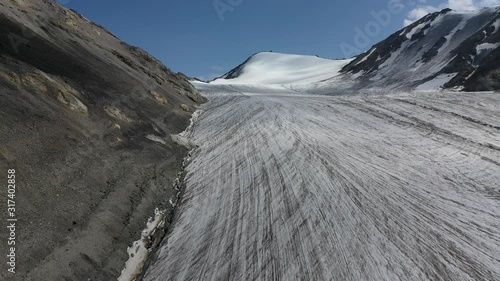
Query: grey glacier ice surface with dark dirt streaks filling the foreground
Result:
<box><xmin>145</xmin><ymin>87</ymin><xmax>500</xmax><ymax>281</ymax></box>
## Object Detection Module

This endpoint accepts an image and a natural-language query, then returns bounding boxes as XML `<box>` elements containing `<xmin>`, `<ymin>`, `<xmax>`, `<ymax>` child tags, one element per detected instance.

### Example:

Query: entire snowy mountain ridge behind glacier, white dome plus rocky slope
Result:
<box><xmin>203</xmin><ymin>7</ymin><xmax>500</xmax><ymax>94</ymax></box>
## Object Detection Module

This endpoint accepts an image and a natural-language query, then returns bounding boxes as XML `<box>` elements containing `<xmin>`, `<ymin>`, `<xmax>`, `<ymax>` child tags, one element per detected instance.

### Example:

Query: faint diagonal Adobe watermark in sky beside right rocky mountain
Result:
<box><xmin>339</xmin><ymin>0</ymin><xmax>406</xmax><ymax>58</ymax></box>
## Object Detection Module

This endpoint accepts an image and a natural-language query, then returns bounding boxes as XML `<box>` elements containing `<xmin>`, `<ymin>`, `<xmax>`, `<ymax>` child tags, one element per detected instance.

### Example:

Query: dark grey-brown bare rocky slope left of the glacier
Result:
<box><xmin>0</xmin><ymin>0</ymin><xmax>202</xmax><ymax>280</ymax></box>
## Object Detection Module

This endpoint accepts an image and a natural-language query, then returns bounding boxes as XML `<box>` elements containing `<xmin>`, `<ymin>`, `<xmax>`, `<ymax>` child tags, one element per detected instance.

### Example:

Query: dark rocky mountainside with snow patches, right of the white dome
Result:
<box><xmin>341</xmin><ymin>8</ymin><xmax>500</xmax><ymax>90</ymax></box>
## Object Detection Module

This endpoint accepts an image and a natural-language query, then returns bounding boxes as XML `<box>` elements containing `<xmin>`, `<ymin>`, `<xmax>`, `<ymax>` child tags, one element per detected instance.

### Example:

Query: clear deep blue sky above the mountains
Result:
<box><xmin>60</xmin><ymin>0</ymin><xmax>500</xmax><ymax>79</ymax></box>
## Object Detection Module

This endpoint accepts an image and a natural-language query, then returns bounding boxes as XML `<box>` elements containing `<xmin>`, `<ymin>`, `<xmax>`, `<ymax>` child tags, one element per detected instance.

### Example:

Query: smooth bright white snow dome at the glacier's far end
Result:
<box><xmin>210</xmin><ymin>52</ymin><xmax>352</xmax><ymax>85</ymax></box>
